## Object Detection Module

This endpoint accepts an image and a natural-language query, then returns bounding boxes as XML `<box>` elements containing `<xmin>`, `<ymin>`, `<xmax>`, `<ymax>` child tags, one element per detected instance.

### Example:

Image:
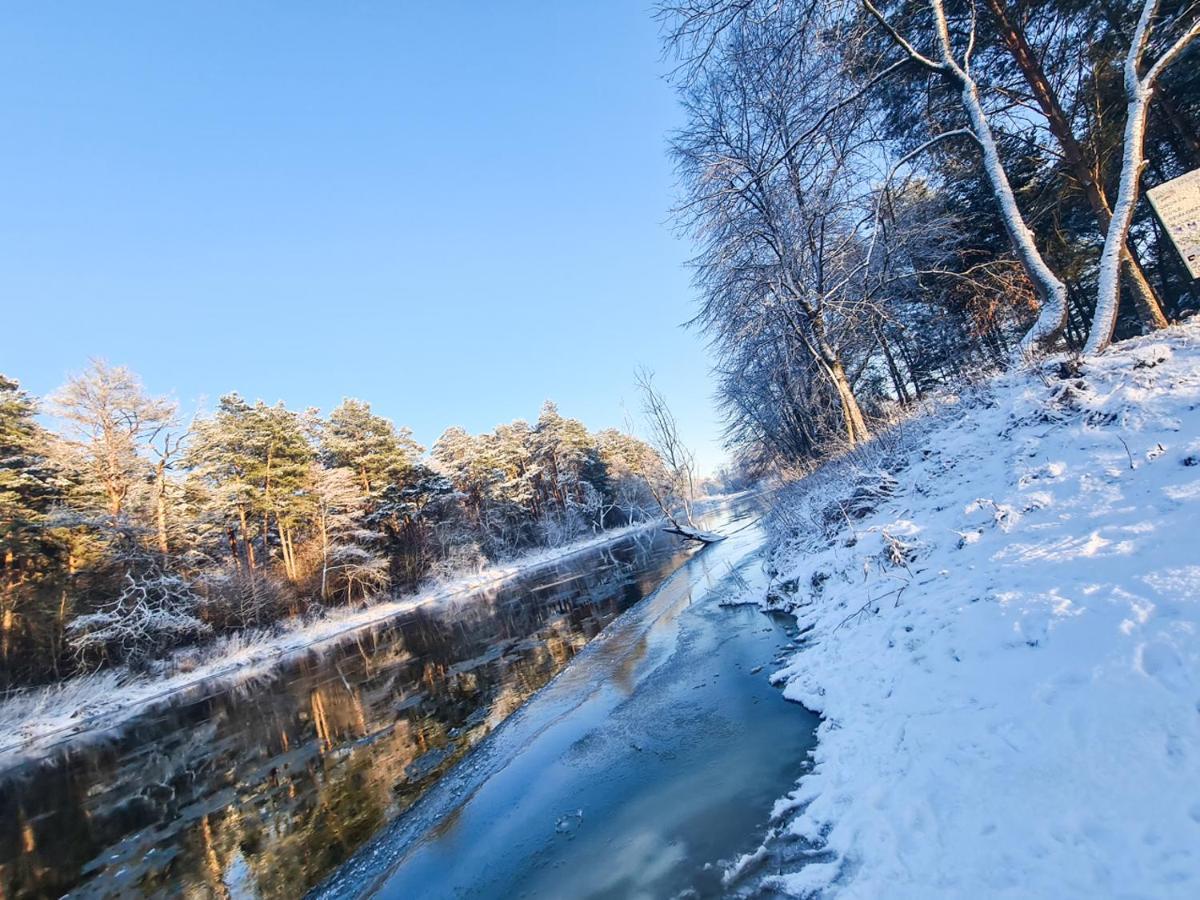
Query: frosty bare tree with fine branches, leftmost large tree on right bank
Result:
<box><xmin>672</xmin><ymin>5</ymin><xmax>871</xmax><ymax>445</ymax></box>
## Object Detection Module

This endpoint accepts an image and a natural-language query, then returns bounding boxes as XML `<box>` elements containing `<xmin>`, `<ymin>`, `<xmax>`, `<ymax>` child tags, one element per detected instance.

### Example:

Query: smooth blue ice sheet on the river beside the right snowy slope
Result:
<box><xmin>318</xmin><ymin>508</ymin><xmax>817</xmax><ymax>900</ymax></box>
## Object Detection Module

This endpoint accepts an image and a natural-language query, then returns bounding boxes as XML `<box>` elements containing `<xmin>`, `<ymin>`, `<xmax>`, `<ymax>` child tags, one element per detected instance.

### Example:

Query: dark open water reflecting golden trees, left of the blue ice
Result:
<box><xmin>0</xmin><ymin>535</ymin><xmax>690</xmax><ymax>898</ymax></box>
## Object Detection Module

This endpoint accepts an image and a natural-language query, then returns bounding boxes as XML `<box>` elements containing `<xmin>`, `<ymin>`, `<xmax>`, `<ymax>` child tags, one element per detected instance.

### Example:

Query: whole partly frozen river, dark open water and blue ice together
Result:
<box><xmin>0</xmin><ymin>502</ymin><xmax>816</xmax><ymax>898</ymax></box>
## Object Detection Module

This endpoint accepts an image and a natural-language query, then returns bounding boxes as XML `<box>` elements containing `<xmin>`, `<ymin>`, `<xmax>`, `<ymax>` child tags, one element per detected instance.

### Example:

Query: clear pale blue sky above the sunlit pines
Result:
<box><xmin>0</xmin><ymin>0</ymin><xmax>721</xmax><ymax>466</ymax></box>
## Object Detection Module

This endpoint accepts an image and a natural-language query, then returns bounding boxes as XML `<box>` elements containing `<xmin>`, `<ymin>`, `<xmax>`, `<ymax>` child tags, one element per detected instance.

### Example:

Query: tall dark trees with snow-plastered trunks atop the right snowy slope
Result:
<box><xmin>660</xmin><ymin>0</ymin><xmax>1200</xmax><ymax>469</ymax></box>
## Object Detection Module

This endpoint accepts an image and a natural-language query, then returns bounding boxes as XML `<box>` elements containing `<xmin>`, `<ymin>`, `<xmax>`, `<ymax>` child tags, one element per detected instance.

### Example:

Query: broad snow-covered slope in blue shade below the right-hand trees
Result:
<box><xmin>743</xmin><ymin>323</ymin><xmax>1200</xmax><ymax>898</ymax></box>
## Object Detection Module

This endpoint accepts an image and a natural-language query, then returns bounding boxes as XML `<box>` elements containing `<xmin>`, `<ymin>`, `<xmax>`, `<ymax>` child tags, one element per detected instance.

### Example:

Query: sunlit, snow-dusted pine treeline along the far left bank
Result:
<box><xmin>0</xmin><ymin>361</ymin><xmax>667</xmax><ymax>686</ymax></box>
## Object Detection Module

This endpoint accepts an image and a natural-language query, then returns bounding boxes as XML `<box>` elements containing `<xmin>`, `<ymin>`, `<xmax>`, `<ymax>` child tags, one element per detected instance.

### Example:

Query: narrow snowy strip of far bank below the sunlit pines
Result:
<box><xmin>0</xmin><ymin>521</ymin><xmax>662</xmax><ymax>770</ymax></box>
